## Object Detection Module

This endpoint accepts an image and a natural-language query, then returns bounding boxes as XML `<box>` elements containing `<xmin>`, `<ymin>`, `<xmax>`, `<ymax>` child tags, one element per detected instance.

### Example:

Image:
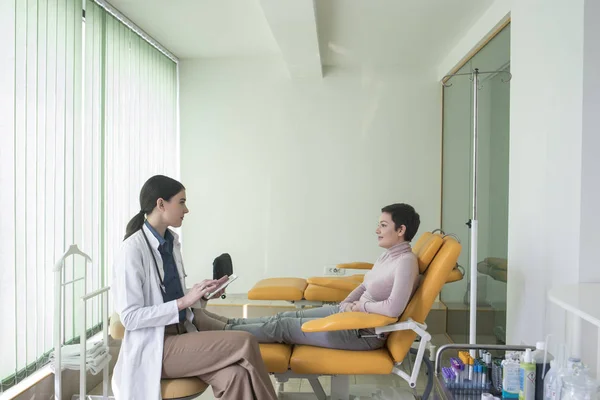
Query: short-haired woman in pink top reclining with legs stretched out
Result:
<box><xmin>225</xmin><ymin>204</ymin><xmax>420</xmax><ymax>350</ymax></box>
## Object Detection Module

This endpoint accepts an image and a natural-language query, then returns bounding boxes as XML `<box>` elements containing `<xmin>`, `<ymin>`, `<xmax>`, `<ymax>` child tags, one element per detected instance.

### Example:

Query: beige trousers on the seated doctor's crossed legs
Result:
<box><xmin>162</xmin><ymin>309</ymin><xmax>277</xmax><ymax>400</ymax></box>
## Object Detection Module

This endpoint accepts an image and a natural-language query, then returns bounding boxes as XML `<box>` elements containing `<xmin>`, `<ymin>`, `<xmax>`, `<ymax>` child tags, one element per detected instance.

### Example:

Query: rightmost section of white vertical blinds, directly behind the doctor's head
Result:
<box><xmin>99</xmin><ymin>0</ymin><xmax>179</xmax><ymax>279</ymax></box>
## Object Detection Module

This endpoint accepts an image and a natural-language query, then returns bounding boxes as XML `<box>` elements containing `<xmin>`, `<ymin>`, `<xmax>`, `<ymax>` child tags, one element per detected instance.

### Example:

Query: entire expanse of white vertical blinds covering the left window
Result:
<box><xmin>0</xmin><ymin>0</ymin><xmax>179</xmax><ymax>393</ymax></box>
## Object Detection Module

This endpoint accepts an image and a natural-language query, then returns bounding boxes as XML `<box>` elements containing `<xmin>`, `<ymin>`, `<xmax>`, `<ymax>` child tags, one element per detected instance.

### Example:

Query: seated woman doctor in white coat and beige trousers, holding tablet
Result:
<box><xmin>113</xmin><ymin>175</ymin><xmax>277</xmax><ymax>400</ymax></box>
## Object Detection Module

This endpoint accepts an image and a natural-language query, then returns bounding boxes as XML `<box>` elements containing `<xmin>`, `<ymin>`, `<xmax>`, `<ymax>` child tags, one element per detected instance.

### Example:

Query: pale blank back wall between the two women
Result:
<box><xmin>181</xmin><ymin>59</ymin><xmax>441</xmax><ymax>292</ymax></box>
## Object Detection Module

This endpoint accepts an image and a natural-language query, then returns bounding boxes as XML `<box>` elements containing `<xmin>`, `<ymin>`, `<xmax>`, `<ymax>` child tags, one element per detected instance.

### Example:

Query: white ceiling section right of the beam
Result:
<box><xmin>316</xmin><ymin>0</ymin><xmax>493</xmax><ymax>66</ymax></box>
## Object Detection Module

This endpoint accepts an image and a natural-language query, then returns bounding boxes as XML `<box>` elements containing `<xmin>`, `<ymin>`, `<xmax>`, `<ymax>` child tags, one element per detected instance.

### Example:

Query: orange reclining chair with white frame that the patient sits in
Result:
<box><xmin>255</xmin><ymin>235</ymin><xmax>461</xmax><ymax>400</ymax></box>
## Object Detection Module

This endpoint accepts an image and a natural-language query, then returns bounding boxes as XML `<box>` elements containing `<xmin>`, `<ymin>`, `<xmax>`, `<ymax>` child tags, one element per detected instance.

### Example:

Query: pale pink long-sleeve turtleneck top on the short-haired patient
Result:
<box><xmin>340</xmin><ymin>242</ymin><xmax>419</xmax><ymax>317</ymax></box>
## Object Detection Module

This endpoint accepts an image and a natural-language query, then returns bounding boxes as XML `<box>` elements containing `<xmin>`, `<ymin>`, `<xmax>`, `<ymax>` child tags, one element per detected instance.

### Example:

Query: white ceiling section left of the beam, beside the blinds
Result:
<box><xmin>109</xmin><ymin>0</ymin><xmax>279</xmax><ymax>58</ymax></box>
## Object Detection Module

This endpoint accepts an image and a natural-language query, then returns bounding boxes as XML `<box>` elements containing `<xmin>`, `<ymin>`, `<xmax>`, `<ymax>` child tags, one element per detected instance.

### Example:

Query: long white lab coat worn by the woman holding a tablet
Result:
<box><xmin>112</xmin><ymin>225</ymin><xmax>195</xmax><ymax>400</ymax></box>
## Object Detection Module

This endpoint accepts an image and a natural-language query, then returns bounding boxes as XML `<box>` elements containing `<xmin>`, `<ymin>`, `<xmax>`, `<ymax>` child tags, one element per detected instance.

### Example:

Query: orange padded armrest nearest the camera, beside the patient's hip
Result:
<box><xmin>302</xmin><ymin>312</ymin><xmax>398</xmax><ymax>332</ymax></box>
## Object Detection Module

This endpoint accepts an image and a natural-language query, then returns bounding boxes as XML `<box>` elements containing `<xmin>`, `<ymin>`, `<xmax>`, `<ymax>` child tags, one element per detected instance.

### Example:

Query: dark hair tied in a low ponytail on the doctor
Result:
<box><xmin>123</xmin><ymin>175</ymin><xmax>185</xmax><ymax>240</ymax></box>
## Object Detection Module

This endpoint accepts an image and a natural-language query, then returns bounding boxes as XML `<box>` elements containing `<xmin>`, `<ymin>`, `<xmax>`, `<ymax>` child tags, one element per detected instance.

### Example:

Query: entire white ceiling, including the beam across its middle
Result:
<box><xmin>110</xmin><ymin>0</ymin><xmax>493</xmax><ymax>76</ymax></box>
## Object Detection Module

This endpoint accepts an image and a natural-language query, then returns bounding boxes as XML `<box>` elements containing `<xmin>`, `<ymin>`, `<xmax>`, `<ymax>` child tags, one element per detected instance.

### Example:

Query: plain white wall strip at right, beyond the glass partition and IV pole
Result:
<box><xmin>507</xmin><ymin>0</ymin><xmax>583</xmax><ymax>343</ymax></box>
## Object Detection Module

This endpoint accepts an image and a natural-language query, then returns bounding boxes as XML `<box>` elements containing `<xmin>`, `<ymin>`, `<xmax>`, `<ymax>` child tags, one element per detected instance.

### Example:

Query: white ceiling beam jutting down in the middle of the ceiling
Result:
<box><xmin>260</xmin><ymin>0</ymin><xmax>323</xmax><ymax>78</ymax></box>
